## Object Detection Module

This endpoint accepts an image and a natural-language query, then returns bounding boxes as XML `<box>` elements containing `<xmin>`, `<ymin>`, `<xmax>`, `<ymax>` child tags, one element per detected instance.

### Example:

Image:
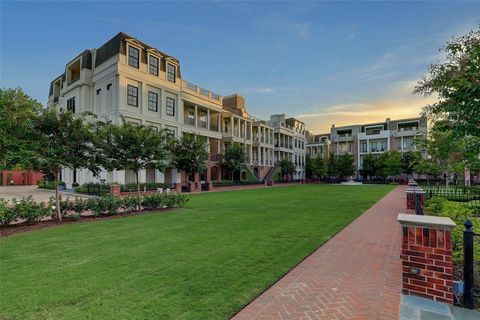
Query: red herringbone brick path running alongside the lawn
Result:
<box><xmin>233</xmin><ymin>186</ymin><xmax>406</xmax><ymax>320</ymax></box>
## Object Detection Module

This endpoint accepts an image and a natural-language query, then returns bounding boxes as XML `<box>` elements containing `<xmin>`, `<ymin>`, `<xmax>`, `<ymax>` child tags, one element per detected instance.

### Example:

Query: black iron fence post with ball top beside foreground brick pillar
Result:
<box><xmin>463</xmin><ymin>220</ymin><xmax>473</xmax><ymax>309</ymax></box>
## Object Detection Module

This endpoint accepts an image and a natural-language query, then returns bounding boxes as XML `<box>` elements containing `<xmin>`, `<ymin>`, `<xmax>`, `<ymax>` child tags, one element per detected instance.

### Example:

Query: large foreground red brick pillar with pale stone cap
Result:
<box><xmin>398</xmin><ymin>213</ymin><xmax>455</xmax><ymax>304</ymax></box>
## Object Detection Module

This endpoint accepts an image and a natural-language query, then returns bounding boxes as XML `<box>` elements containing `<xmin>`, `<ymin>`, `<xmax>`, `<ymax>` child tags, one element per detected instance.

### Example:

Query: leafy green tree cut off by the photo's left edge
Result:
<box><xmin>0</xmin><ymin>88</ymin><xmax>43</xmax><ymax>170</ymax></box>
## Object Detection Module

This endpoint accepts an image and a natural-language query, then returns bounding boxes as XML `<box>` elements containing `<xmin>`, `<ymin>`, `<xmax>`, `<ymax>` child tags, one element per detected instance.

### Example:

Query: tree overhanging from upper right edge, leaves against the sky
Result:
<box><xmin>414</xmin><ymin>28</ymin><xmax>480</xmax><ymax>137</ymax></box>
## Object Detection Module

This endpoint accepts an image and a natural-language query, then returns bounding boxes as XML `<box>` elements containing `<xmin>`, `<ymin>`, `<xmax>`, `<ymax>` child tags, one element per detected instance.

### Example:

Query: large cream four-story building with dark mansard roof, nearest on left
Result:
<box><xmin>48</xmin><ymin>33</ymin><xmax>226</xmax><ymax>185</ymax></box>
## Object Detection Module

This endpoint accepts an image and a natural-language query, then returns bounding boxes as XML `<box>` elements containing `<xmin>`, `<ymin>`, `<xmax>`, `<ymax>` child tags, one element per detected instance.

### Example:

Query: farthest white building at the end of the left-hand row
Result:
<box><xmin>268</xmin><ymin>114</ymin><xmax>306</xmax><ymax>179</ymax></box>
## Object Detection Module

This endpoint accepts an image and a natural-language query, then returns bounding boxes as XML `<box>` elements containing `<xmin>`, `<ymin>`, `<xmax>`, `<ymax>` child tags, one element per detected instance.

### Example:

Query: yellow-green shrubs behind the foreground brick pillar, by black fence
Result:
<box><xmin>425</xmin><ymin>197</ymin><xmax>480</xmax><ymax>263</ymax></box>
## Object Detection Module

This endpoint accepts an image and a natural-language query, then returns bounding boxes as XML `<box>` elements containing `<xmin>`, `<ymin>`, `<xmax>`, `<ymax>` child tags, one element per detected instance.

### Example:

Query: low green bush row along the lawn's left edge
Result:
<box><xmin>0</xmin><ymin>193</ymin><xmax>188</xmax><ymax>226</ymax></box>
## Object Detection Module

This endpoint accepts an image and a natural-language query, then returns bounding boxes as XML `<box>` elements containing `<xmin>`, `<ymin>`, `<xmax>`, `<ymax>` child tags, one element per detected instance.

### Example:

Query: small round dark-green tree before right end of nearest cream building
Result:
<box><xmin>169</xmin><ymin>133</ymin><xmax>208</xmax><ymax>185</ymax></box>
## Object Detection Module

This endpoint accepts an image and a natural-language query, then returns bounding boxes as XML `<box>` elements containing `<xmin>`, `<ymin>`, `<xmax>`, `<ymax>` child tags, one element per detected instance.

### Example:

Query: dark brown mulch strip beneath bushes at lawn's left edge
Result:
<box><xmin>0</xmin><ymin>208</ymin><xmax>178</xmax><ymax>238</ymax></box>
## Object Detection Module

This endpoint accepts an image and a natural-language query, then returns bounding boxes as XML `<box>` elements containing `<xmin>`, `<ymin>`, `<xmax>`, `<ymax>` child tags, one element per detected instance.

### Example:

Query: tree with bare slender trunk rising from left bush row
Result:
<box><xmin>31</xmin><ymin>109</ymin><xmax>101</xmax><ymax>220</ymax></box>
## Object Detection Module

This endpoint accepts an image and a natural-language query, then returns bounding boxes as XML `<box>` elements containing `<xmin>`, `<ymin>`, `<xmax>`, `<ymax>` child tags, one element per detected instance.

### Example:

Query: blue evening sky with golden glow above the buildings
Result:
<box><xmin>0</xmin><ymin>0</ymin><xmax>480</xmax><ymax>133</ymax></box>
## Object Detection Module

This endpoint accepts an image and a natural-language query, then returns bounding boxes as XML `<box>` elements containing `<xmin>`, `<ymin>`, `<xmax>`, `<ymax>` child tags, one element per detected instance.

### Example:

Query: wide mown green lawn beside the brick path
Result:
<box><xmin>0</xmin><ymin>185</ymin><xmax>393</xmax><ymax>319</ymax></box>
